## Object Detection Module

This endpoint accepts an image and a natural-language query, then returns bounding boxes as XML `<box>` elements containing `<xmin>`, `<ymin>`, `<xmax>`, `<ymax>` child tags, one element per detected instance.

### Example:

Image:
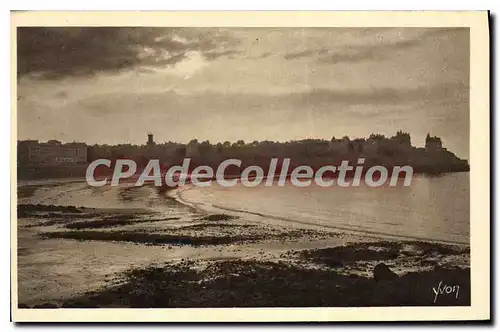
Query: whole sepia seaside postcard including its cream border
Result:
<box><xmin>11</xmin><ymin>12</ymin><xmax>490</xmax><ymax>322</ymax></box>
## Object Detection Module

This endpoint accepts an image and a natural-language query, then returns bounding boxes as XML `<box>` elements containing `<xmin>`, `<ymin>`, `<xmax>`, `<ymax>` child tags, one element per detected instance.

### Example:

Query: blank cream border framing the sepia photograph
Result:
<box><xmin>11</xmin><ymin>11</ymin><xmax>490</xmax><ymax>322</ymax></box>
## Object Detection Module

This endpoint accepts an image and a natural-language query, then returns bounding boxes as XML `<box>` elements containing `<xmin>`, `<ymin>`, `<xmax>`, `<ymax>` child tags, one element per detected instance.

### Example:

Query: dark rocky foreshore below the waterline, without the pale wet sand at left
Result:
<box><xmin>18</xmin><ymin>205</ymin><xmax>470</xmax><ymax>308</ymax></box>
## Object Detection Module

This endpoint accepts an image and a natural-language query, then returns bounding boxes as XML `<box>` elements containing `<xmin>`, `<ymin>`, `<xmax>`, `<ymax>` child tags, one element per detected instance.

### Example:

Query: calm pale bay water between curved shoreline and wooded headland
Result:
<box><xmin>178</xmin><ymin>173</ymin><xmax>470</xmax><ymax>244</ymax></box>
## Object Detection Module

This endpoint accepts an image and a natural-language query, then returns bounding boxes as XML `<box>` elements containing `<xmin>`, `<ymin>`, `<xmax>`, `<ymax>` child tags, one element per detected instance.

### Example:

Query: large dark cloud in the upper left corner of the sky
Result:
<box><xmin>17</xmin><ymin>27</ymin><xmax>237</xmax><ymax>79</ymax></box>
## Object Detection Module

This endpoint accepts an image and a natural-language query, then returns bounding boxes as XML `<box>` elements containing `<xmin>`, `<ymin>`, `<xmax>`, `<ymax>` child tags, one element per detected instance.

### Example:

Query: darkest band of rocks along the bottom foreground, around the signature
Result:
<box><xmin>56</xmin><ymin>259</ymin><xmax>471</xmax><ymax>308</ymax></box>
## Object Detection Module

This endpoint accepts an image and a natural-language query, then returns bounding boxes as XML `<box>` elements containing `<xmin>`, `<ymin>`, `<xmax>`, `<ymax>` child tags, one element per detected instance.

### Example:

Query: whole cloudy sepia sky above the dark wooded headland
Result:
<box><xmin>17</xmin><ymin>28</ymin><xmax>469</xmax><ymax>158</ymax></box>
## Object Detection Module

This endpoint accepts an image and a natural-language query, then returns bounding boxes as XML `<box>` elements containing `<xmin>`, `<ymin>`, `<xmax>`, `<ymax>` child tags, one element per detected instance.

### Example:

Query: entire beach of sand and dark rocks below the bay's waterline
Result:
<box><xmin>14</xmin><ymin>201</ymin><xmax>470</xmax><ymax>308</ymax></box>
